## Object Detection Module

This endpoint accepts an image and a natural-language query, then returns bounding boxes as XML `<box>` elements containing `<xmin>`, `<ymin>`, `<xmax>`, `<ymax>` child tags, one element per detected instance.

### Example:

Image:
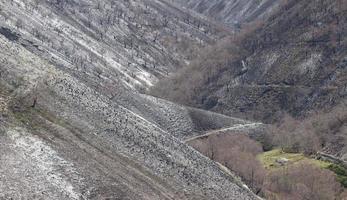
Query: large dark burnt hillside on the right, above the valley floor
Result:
<box><xmin>153</xmin><ymin>0</ymin><xmax>347</xmax><ymax>122</ymax></box>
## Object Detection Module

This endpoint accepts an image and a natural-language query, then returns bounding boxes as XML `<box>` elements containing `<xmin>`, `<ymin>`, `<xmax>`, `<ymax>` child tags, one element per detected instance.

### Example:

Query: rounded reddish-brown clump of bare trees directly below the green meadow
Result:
<box><xmin>264</xmin><ymin>163</ymin><xmax>341</xmax><ymax>200</ymax></box>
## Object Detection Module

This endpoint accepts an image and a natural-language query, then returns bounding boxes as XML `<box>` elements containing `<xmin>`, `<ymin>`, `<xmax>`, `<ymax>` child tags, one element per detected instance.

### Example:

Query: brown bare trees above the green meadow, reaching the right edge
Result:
<box><xmin>261</xmin><ymin>104</ymin><xmax>347</xmax><ymax>155</ymax></box>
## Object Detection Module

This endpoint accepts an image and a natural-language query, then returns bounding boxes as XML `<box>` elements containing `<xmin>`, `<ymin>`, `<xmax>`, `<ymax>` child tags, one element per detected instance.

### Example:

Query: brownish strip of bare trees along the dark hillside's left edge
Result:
<box><xmin>150</xmin><ymin>27</ymin><xmax>254</xmax><ymax>106</ymax></box>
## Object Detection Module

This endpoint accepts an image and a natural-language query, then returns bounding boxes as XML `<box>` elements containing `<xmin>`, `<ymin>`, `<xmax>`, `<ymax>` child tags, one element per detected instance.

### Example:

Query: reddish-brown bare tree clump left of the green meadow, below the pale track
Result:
<box><xmin>190</xmin><ymin>133</ymin><xmax>266</xmax><ymax>194</ymax></box>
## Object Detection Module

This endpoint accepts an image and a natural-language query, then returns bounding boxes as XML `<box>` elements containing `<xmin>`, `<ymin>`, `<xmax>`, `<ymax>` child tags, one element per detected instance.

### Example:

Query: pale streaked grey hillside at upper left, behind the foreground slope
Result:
<box><xmin>1</xmin><ymin>1</ymin><xmax>227</xmax><ymax>90</ymax></box>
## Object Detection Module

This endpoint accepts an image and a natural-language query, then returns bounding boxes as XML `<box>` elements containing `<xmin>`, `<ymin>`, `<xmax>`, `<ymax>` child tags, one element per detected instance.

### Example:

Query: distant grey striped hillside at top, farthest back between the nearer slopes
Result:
<box><xmin>175</xmin><ymin>0</ymin><xmax>281</xmax><ymax>28</ymax></box>
